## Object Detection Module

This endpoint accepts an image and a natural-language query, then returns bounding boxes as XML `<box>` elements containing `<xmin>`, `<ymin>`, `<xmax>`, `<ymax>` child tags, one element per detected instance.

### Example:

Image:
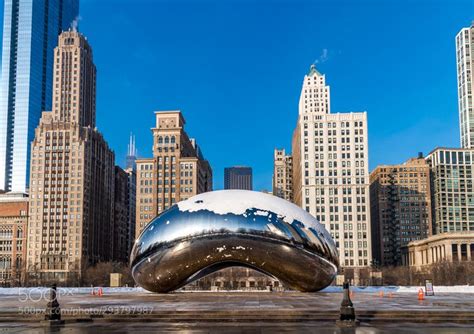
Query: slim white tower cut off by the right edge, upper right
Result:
<box><xmin>456</xmin><ymin>22</ymin><xmax>474</xmax><ymax>148</ymax></box>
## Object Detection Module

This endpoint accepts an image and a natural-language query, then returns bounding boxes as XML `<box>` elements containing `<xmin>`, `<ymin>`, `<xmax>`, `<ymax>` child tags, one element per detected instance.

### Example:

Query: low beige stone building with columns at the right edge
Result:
<box><xmin>402</xmin><ymin>232</ymin><xmax>474</xmax><ymax>268</ymax></box>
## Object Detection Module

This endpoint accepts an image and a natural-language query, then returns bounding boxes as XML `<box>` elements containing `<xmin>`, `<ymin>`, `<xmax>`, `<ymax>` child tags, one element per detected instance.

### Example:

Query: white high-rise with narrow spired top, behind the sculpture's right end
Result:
<box><xmin>292</xmin><ymin>65</ymin><xmax>372</xmax><ymax>267</ymax></box>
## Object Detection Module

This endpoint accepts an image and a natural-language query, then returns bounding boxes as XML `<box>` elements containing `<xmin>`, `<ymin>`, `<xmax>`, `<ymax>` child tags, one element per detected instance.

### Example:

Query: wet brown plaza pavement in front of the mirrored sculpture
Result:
<box><xmin>0</xmin><ymin>289</ymin><xmax>474</xmax><ymax>326</ymax></box>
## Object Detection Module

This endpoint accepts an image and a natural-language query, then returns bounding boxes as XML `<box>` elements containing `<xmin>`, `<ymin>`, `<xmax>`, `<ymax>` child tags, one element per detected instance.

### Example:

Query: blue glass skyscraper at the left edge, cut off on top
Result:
<box><xmin>0</xmin><ymin>0</ymin><xmax>79</xmax><ymax>192</ymax></box>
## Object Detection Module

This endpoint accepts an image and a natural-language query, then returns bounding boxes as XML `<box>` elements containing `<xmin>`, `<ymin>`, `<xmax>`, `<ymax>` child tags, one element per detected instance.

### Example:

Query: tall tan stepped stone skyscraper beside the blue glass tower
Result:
<box><xmin>27</xmin><ymin>31</ymin><xmax>115</xmax><ymax>281</ymax></box>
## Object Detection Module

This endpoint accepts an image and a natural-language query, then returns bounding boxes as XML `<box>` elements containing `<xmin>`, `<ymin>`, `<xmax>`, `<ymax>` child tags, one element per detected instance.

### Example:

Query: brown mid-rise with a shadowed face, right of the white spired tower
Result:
<box><xmin>370</xmin><ymin>154</ymin><xmax>433</xmax><ymax>266</ymax></box>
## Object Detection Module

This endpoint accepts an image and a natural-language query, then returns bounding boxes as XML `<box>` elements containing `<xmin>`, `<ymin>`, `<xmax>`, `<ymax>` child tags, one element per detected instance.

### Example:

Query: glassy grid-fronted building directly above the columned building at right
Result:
<box><xmin>426</xmin><ymin>148</ymin><xmax>474</xmax><ymax>234</ymax></box>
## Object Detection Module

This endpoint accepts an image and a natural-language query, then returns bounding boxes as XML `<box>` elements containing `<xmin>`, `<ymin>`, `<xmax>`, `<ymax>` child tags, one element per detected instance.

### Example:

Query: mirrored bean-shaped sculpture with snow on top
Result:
<box><xmin>130</xmin><ymin>190</ymin><xmax>338</xmax><ymax>293</ymax></box>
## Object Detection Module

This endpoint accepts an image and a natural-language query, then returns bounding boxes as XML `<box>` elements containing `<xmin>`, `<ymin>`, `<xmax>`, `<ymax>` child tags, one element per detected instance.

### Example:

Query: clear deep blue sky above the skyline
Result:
<box><xmin>0</xmin><ymin>0</ymin><xmax>474</xmax><ymax>190</ymax></box>
